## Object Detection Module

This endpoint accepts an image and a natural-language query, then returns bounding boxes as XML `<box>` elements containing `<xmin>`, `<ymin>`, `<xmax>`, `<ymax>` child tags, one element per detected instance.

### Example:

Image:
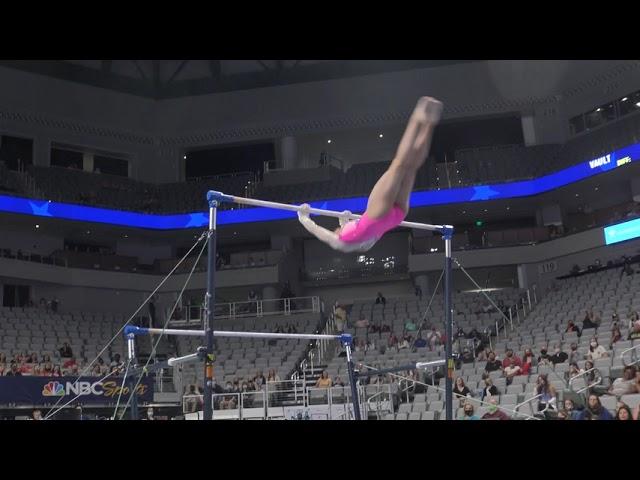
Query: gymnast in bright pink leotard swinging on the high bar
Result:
<box><xmin>298</xmin><ymin>97</ymin><xmax>442</xmax><ymax>253</ymax></box>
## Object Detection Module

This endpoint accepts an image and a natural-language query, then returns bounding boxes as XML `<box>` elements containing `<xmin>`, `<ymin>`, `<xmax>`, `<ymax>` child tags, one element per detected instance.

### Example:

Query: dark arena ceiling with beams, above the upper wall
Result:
<box><xmin>0</xmin><ymin>60</ymin><xmax>477</xmax><ymax>100</ymax></box>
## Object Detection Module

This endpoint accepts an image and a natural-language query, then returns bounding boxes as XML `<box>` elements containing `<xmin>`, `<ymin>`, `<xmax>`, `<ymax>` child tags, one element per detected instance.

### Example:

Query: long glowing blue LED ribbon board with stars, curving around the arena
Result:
<box><xmin>0</xmin><ymin>143</ymin><xmax>640</xmax><ymax>230</ymax></box>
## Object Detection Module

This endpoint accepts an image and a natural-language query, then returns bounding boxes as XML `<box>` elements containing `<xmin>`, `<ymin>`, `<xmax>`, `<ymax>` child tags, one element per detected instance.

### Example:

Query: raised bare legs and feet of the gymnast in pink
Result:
<box><xmin>367</xmin><ymin>97</ymin><xmax>442</xmax><ymax>219</ymax></box>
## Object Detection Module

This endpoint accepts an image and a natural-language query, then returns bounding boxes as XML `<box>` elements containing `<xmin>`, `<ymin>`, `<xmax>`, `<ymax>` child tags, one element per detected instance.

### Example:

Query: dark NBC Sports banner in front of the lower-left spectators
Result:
<box><xmin>0</xmin><ymin>376</ymin><xmax>154</xmax><ymax>405</ymax></box>
